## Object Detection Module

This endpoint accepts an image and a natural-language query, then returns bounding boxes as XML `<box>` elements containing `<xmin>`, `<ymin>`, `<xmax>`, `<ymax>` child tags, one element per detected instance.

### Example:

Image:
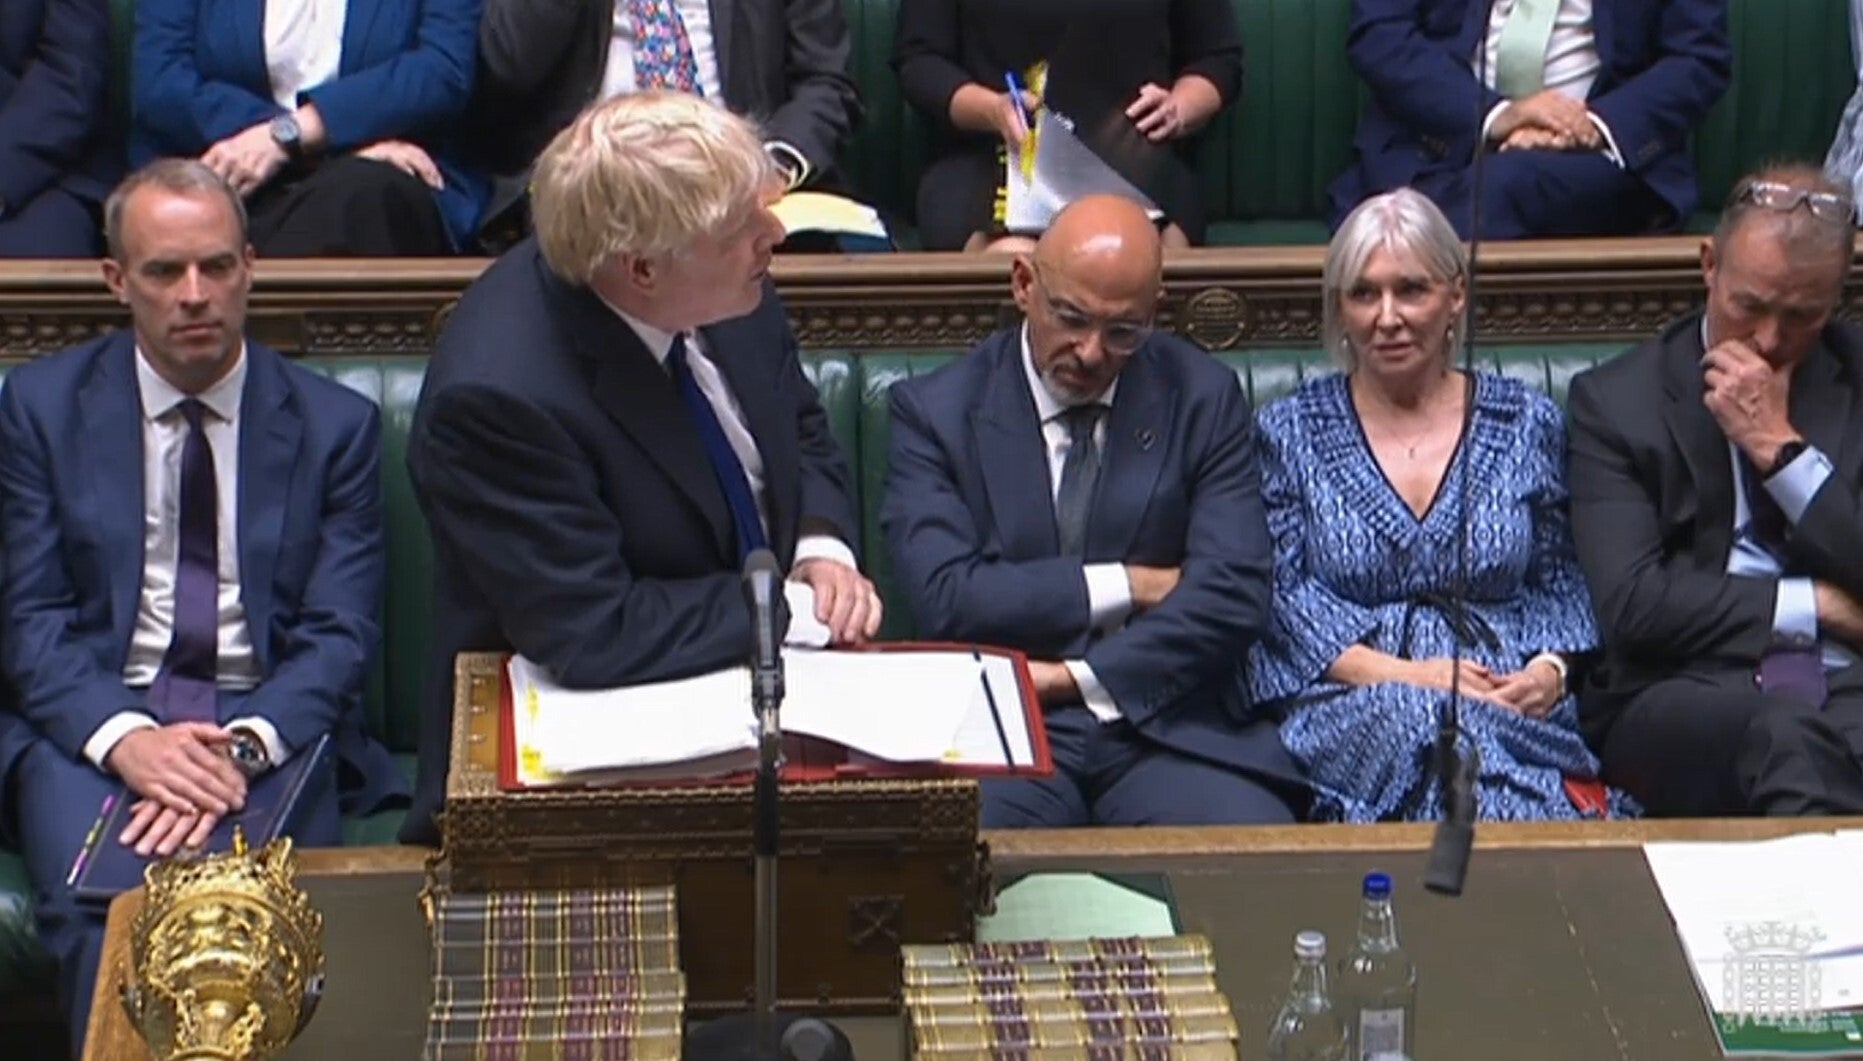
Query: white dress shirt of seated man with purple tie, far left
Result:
<box><xmin>84</xmin><ymin>346</ymin><xmax>289</xmax><ymax>769</ymax></box>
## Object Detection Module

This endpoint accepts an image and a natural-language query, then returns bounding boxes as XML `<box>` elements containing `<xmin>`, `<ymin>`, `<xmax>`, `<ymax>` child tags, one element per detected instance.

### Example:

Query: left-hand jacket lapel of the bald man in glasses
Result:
<box><xmin>971</xmin><ymin>331</ymin><xmax>1060</xmax><ymax>560</ymax></box>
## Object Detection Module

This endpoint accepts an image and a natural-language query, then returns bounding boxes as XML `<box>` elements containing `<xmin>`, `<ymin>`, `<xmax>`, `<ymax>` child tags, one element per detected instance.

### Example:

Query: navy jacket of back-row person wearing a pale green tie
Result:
<box><xmin>1332</xmin><ymin>0</ymin><xmax>1733</xmax><ymax>223</ymax></box>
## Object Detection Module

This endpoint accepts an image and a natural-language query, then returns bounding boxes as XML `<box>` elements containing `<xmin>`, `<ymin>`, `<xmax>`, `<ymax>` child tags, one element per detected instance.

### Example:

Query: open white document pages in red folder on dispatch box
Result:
<box><xmin>507</xmin><ymin>644</ymin><xmax>1053</xmax><ymax>787</ymax></box>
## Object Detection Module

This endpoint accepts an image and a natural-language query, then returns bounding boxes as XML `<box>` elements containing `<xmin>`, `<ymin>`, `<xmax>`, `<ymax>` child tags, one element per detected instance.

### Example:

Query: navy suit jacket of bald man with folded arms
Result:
<box><xmin>881</xmin><ymin>329</ymin><xmax>1300</xmax><ymax>782</ymax></box>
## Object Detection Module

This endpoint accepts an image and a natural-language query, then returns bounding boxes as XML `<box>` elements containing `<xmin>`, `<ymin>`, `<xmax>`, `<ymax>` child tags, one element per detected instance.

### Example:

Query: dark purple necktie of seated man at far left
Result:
<box><xmin>149</xmin><ymin>398</ymin><xmax>220</xmax><ymax>722</ymax></box>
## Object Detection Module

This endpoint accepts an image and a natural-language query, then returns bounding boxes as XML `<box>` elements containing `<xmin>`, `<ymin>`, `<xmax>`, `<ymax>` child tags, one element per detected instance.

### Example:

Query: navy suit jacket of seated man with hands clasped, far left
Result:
<box><xmin>0</xmin><ymin>331</ymin><xmax>402</xmax><ymax>826</ymax></box>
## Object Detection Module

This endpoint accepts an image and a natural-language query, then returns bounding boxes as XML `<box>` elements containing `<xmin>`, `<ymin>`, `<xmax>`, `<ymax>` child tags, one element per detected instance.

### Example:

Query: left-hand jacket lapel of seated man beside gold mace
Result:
<box><xmin>76</xmin><ymin>331</ymin><xmax>147</xmax><ymax>650</ymax></box>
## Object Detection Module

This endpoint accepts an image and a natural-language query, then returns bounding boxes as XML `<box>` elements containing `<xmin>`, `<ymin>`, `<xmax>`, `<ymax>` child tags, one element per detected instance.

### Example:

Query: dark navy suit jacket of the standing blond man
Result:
<box><xmin>402</xmin><ymin>240</ymin><xmax>857</xmax><ymax>841</ymax></box>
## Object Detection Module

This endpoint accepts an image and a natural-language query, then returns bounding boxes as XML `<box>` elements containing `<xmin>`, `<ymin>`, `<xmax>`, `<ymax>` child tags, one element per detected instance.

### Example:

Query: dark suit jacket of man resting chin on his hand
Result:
<box><xmin>1567</xmin><ymin>315</ymin><xmax>1863</xmax><ymax>735</ymax></box>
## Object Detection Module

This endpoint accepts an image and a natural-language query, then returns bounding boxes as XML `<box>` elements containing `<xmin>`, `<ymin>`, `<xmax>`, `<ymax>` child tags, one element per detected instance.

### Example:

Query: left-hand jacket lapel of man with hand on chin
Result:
<box><xmin>1664</xmin><ymin>316</ymin><xmax>1734</xmax><ymax>568</ymax></box>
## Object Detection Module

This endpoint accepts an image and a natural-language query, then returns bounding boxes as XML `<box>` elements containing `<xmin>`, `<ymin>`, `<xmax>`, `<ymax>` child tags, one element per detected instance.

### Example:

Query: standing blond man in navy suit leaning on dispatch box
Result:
<box><xmin>402</xmin><ymin>91</ymin><xmax>879</xmax><ymax>843</ymax></box>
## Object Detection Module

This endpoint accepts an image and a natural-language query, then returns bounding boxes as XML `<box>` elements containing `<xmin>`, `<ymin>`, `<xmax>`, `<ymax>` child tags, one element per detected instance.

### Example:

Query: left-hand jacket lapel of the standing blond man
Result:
<box><xmin>562</xmin><ymin>279</ymin><xmax>738</xmax><ymax>564</ymax></box>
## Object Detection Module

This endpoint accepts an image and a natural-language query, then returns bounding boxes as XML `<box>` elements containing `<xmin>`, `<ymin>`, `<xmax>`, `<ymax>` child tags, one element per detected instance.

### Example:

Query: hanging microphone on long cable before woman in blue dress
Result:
<box><xmin>1423</xmin><ymin>12</ymin><xmax>1489</xmax><ymax>895</ymax></box>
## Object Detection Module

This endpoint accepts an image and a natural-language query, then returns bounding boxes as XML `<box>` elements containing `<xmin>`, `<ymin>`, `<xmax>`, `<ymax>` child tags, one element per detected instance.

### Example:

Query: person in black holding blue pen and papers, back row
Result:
<box><xmin>892</xmin><ymin>0</ymin><xmax>1243</xmax><ymax>253</ymax></box>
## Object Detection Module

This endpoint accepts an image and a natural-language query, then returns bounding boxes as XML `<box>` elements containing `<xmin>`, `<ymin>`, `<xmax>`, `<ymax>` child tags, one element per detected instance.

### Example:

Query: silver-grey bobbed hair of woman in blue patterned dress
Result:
<box><xmin>1319</xmin><ymin>188</ymin><xmax>1468</xmax><ymax>372</ymax></box>
